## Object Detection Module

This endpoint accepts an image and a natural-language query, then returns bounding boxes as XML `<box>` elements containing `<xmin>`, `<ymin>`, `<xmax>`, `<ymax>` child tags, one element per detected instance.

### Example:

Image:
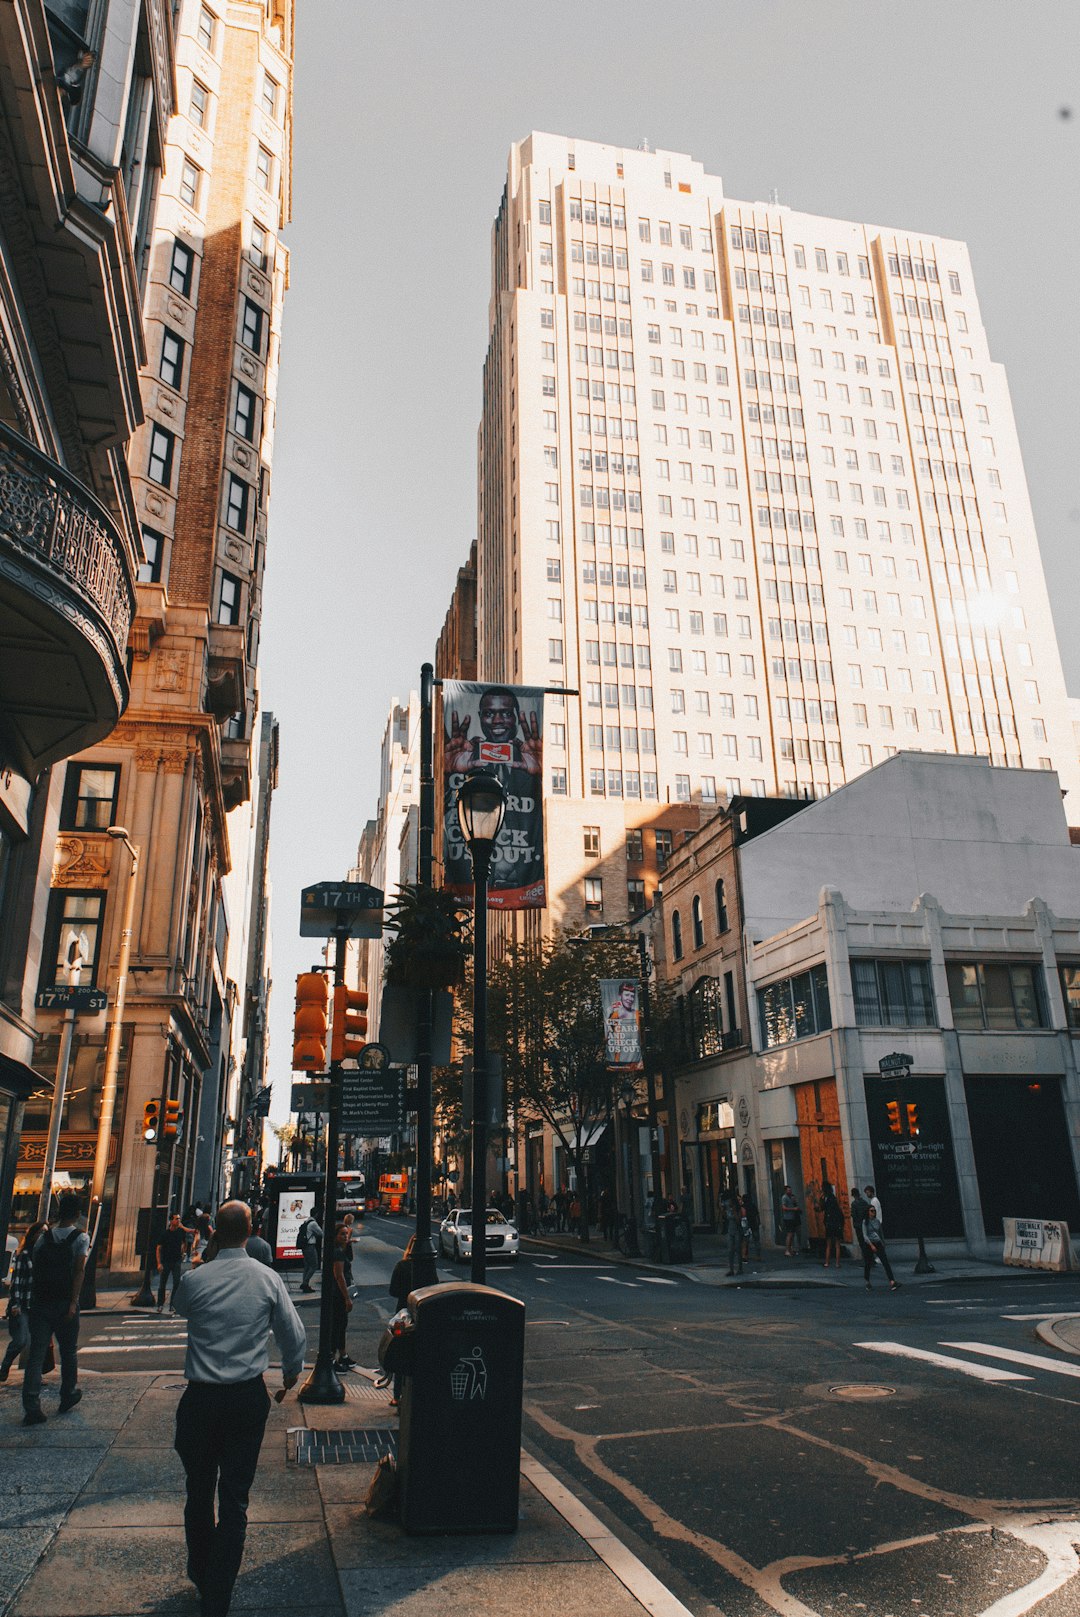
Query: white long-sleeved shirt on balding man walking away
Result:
<box><xmin>173</xmin><ymin>1247</ymin><xmax>307</xmax><ymax>1384</ymax></box>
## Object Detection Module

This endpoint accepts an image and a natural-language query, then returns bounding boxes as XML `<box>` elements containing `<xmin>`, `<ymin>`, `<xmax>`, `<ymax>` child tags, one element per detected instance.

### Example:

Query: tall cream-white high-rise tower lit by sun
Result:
<box><xmin>479</xmin><ymin>133</ymin><xmax>1080</xmax><ymax>920</ymax></box>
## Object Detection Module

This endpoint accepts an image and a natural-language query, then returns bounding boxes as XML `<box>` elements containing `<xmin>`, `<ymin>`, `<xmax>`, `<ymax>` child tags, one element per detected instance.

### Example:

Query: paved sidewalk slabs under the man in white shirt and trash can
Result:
<box><xmin>0</xmin><ymin>1368</ymin><xmax>675</xmax><ymax>1617</ymax></box>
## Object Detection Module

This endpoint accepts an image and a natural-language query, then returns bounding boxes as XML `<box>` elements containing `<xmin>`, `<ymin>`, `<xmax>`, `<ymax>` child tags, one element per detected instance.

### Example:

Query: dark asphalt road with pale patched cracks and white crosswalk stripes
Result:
<box><xmin>82</xmin><ymin>1218</ymin><xmax>1080</xmax><ymax>1617</ymax></box>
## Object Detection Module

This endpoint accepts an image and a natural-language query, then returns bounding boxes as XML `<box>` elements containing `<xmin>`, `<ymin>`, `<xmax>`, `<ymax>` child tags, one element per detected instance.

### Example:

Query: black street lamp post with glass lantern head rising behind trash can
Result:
<box><xmin>458</xmin><ymin>771</ymin><xmax>506</xmax><ymax>1286</ymax></box>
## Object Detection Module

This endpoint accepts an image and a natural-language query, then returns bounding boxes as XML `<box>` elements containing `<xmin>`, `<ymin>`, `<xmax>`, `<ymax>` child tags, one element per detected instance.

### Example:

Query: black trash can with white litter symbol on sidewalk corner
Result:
<box><xmin>389</xmin><ymin>1282</ymin><xmax>525</xmax><ymax>1533</ymax></box>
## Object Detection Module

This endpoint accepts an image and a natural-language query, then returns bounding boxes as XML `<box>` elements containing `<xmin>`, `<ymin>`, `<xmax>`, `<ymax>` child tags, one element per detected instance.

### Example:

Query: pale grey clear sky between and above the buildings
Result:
<box><xmin>260</xmin><ymin>0</ymin><xmax>1080</xmax><ymax>1116</ymax></box>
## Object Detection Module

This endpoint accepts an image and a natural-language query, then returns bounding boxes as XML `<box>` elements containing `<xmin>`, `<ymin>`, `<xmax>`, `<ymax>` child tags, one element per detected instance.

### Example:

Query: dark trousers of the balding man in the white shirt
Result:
<box><xmin>175</xmin><ymin>1376</ymin><xmax>270</xmax><ymax>1617</ymax></box>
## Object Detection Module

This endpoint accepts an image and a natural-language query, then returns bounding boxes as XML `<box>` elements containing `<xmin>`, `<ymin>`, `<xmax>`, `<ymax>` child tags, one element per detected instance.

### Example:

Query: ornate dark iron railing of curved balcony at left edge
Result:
<box><xmin>0</xmin><ymin>422</ymin><xmax>136</xmax><ymax>661</ymax></box>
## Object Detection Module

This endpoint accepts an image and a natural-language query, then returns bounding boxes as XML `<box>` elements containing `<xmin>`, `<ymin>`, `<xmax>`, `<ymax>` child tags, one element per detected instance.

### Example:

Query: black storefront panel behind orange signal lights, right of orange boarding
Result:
<box><xmin>863</xmin><ymin>1072</ymin><xmax>964</xmax><ymax>1242</ymax></box>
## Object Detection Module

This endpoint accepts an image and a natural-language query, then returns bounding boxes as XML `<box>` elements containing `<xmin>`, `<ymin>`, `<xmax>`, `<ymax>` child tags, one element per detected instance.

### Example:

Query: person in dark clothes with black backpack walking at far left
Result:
<box><xmin>23</xmin><ymin>1190</ymin><xmax>91</xmax><ymax>1426</ymax></box>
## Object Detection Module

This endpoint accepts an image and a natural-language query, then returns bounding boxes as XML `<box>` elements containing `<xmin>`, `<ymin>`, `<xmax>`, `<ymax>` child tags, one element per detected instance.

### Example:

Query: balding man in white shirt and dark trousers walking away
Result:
<box><xmin>173</xmin><ymin>1201</ymin><xmax>307</xmax><ymax>1617</ymax></box>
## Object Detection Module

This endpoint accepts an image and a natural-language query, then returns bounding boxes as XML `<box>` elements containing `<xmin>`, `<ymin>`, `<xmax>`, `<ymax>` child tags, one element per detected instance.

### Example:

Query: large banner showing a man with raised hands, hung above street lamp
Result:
<box><xmin>443</xmin><ymin>679</ymin><xmax>546</xmax><ymax>909</ymax></box>
